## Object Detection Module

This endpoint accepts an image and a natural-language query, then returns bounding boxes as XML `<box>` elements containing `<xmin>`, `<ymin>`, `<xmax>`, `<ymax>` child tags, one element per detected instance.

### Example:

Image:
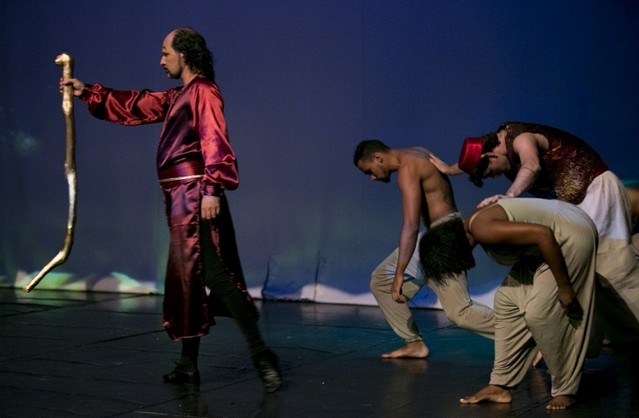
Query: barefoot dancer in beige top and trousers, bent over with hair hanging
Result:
<box><xmin>420</xmin><ymin>198</ymin><xmax>597</xmax><ymax>410</ymax></box>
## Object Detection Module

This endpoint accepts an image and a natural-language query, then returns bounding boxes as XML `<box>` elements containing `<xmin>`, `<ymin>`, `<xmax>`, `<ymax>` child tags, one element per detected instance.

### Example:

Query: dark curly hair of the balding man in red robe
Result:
<box><xmin>171</xmin><ymin>27</ymin><xmax>215</xmax><ymax>82</ymax></box>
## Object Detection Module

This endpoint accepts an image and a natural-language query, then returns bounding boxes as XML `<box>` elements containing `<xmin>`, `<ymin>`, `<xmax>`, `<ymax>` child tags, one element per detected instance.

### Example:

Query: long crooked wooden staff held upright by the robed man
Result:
<box><xmin>24</xmin><ymin>53</ymin><xmax>78</xmax><ymax>292</ymax></box>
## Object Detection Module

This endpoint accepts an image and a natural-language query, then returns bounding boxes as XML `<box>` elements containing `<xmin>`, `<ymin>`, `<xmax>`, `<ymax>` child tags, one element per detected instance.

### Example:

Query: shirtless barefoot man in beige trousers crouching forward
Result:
<box><xmin>353</xmin><ymin>140</ymin><xmax>494</xmax><ymax>358</ymax></box>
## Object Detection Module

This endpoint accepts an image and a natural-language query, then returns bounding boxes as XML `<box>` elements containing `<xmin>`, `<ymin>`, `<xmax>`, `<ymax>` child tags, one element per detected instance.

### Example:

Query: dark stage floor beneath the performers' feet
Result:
<box><xmin>0</xmin><ymin>289</ymin><xmax>639</xmax><ymax>418</ymax></box>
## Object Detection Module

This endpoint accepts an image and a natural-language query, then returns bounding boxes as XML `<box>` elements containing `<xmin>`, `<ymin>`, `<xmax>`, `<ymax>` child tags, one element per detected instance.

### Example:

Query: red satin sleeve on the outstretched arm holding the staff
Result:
<box><xmin>80</xmin><ymin>84</ymin><xmax>171</xmax><ymax>126</ymax></box>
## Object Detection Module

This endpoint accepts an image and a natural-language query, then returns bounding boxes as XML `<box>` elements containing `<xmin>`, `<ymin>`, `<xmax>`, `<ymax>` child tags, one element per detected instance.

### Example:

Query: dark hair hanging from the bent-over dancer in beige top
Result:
<box><xmin>419</xmin><ymin>218</ymin><xmax>475</xmax><ymax>285</ymax></box>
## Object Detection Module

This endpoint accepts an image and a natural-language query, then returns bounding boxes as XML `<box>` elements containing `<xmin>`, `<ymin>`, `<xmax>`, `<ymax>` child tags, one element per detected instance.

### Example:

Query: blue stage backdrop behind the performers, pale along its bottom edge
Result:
<box><xmin>0</xmin><ymin>0</ymin><xmax>639</xmax><ymax>306</ymax></box>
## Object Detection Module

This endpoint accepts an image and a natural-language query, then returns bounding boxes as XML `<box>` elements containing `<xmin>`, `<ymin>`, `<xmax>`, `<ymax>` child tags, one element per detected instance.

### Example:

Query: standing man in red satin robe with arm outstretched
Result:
<box><xmin>60</xmin><ymin>28</ymin><xmax>281</xmax><ymax>392</ymax></box>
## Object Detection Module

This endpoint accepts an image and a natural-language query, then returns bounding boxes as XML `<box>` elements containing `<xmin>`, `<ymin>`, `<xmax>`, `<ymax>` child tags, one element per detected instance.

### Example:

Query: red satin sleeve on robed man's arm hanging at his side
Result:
<box><xmin>190</xmin><ymin>82</ymin><xmax>240</xmax><ymax>196</ymax></box>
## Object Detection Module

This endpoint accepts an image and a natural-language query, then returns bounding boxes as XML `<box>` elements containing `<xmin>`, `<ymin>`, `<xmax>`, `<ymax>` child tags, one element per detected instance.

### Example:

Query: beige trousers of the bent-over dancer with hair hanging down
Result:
<box><xmin>490</xmin><ymin>237</ymin><xmax>595</xmax><ymax>396</ymax></box>
